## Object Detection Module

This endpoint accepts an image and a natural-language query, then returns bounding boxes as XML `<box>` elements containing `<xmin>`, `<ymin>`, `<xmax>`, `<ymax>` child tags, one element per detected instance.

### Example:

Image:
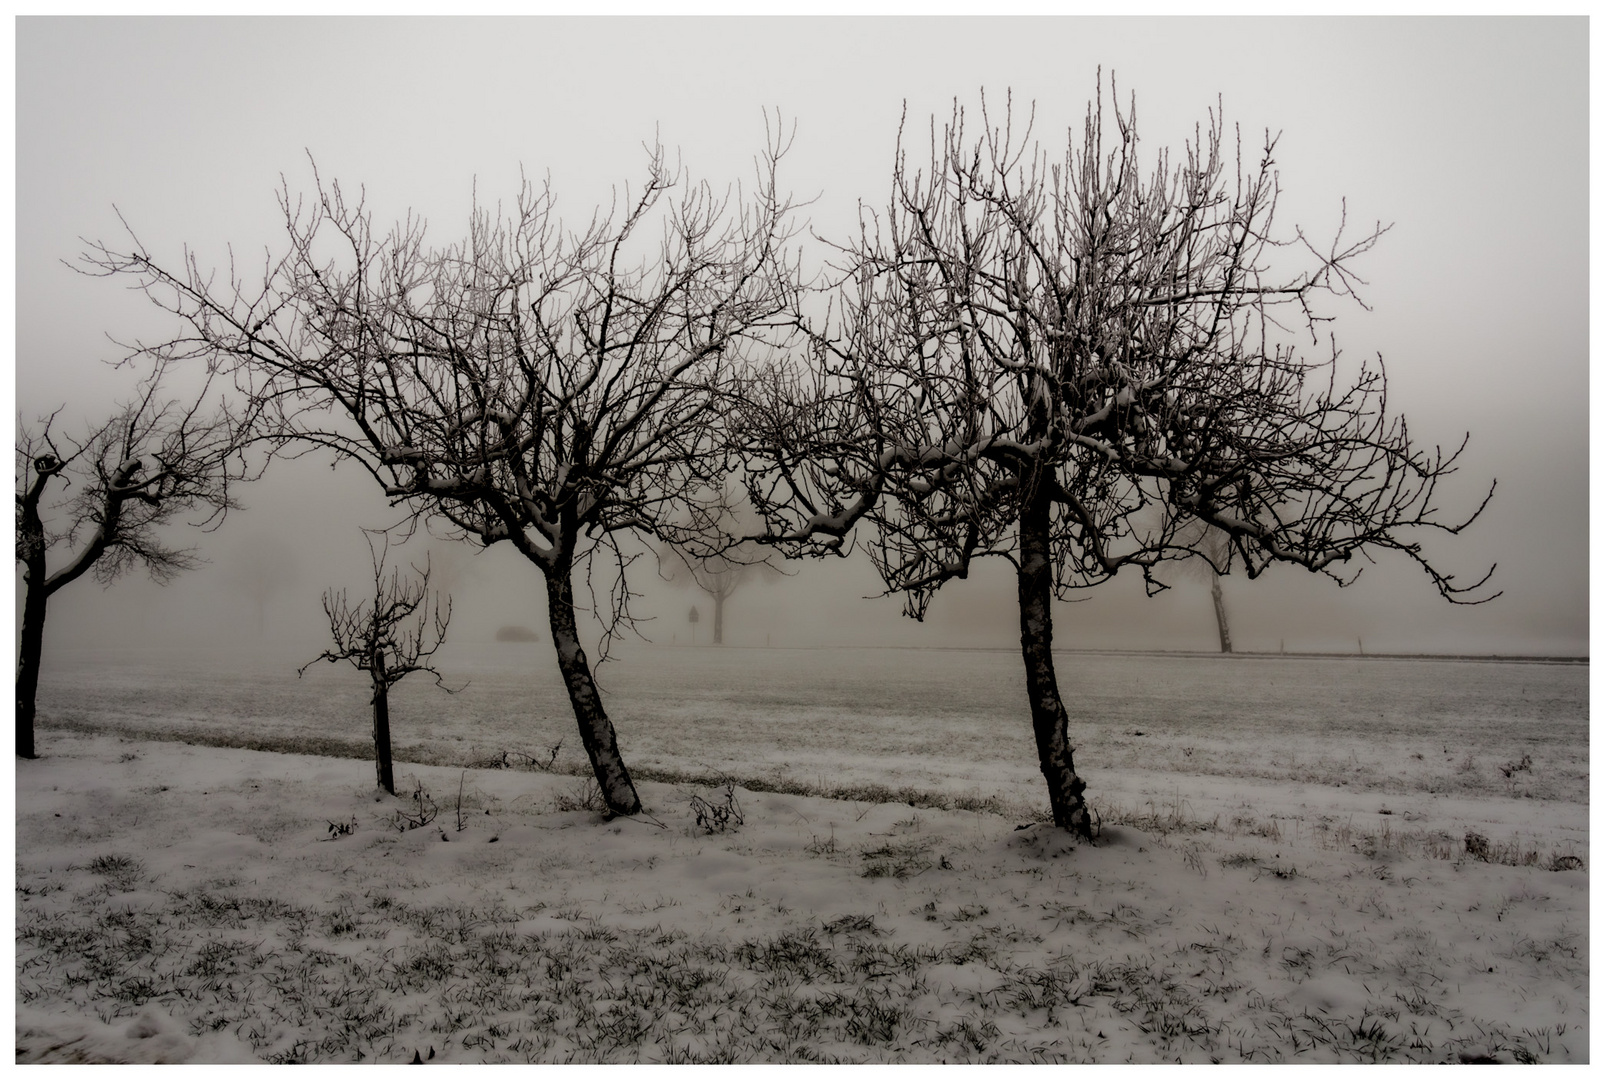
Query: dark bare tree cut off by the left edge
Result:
<box><xmin>16</xmin><ymin>358</ymin><xmax>250</xmax><ymax>757</ymax></box>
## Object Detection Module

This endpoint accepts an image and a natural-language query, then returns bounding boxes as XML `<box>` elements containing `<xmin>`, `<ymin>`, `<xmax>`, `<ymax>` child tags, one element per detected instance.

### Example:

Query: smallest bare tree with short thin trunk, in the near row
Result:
<box><xmin>295</xmin><ymin>534</ymin><xmax>461</xmax><ymax>794</ymax></box>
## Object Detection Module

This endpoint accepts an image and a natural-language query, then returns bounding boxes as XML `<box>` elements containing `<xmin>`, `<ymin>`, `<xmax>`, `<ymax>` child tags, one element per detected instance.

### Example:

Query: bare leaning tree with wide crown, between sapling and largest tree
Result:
<box><xmin>87</xmin><ymin>126</ymin><xmax>793</xmax><ymax>814</ymax></box>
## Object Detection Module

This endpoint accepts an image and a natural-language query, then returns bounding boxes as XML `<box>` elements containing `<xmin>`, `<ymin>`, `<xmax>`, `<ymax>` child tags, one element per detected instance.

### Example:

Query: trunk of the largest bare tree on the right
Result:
<box><xmin>1019</xmin><ymin>494</ymin><xmax>1091</xmax><ymax>839</ymax></box>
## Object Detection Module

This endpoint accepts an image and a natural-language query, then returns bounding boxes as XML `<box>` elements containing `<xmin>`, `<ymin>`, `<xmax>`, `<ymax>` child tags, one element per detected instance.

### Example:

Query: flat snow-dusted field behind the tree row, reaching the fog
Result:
<box><xmin>31</xmin><ymin>644</ymin><xmax>1589</xmax><ymax>806</ymax></box>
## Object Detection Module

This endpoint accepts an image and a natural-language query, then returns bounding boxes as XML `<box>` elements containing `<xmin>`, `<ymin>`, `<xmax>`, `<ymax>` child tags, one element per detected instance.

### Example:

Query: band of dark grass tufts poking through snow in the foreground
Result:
<box><xmin>16</xmin><ymin>857</ymin><xmax>1586</xmax><ymax>1062</ymax></box>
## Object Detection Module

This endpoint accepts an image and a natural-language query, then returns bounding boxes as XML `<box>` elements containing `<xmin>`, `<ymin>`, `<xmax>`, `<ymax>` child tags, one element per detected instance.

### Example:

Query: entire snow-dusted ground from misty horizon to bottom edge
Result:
<box><xmin>16</xmin><ymin>645</ymin><xmax>1589</xmax><ymax>1062</ymax></box>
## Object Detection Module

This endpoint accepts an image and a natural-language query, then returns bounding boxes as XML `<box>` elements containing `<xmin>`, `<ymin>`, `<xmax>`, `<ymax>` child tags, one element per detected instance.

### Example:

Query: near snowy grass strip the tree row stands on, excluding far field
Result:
<box><xmin>16</xmin><ymin>737</ymin><xmax>1589</xmax><ymax>1062</ymax></box>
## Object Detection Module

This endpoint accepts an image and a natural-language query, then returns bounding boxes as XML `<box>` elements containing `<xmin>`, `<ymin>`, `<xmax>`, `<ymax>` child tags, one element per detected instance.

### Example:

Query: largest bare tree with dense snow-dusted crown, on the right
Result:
<box><xmin>740</xmin><ymin>87</ymin><xmax>1491</xmax><ymax>834</ymax></box>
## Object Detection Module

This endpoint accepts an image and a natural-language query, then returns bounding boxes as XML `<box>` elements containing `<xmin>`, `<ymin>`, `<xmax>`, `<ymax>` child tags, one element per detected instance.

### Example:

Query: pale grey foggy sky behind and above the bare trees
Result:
<box><xmin>6</xmin><ymin>18</ymin><xmax>1589</xmax><ymax>653</ymax></box>
